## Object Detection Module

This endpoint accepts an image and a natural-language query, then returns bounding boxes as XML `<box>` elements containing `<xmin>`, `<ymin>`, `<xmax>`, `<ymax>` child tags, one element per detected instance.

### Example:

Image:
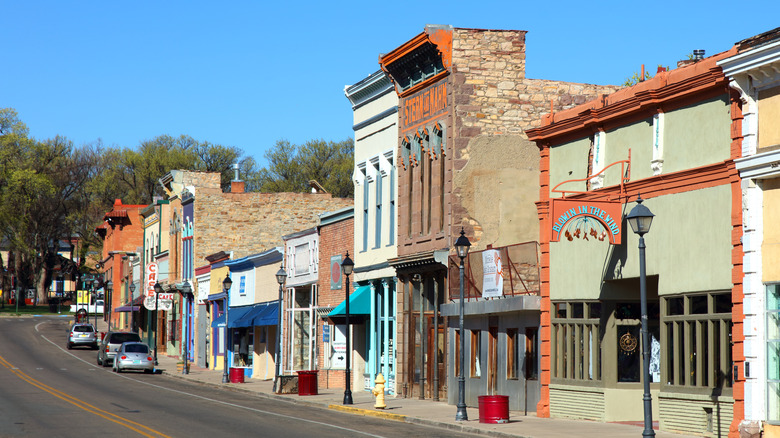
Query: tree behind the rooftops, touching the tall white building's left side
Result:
<box><xmin>249</xmin><ymin>139</ymin><xmax>355</xmax><ymax>198</ymax></box>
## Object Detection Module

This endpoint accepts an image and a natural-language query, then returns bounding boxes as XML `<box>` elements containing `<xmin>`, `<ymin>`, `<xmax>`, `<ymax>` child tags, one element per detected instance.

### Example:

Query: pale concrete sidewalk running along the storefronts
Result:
<box><xmin>148</xmin><ymin>354</ymin><xmax>690</xmax><ymax>438</ymax></box>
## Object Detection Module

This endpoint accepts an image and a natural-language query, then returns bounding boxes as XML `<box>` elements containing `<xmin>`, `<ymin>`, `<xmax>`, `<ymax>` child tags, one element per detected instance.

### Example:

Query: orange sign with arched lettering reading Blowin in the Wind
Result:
<box><xmin>550</xmin><ymin>199</ymin><xmax>623</xmax><ymax>245</ymax></box>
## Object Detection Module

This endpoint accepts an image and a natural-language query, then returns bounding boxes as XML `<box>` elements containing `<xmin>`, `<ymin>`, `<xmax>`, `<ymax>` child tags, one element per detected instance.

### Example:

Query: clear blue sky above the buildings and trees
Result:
<box><xmin>0</xmin><ymin>0</ymin><xmax>780</xmax><ymax>165</ymax></box>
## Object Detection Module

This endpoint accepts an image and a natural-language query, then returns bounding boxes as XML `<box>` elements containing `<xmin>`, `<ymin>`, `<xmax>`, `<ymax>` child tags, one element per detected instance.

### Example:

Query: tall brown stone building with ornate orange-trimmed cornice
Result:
<box><xmin>379</xmin><ymin>26</ymin><xmax>616</xmax><ymax>410</ymax></box>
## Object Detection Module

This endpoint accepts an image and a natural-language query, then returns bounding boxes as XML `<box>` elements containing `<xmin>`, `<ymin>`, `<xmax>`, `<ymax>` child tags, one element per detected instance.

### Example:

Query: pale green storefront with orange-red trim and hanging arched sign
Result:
<box><xmin>528</xmin><ymin>48</ymin><xmax>746</xmax><ymax>436</ymax></box>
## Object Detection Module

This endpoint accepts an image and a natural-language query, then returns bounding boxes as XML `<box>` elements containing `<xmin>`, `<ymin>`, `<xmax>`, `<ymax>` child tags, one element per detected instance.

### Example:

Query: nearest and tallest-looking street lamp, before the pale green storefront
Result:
<box><xmin>626</xmin><ymin>194</ymin><xmax>655</xmax><ymax>437</ymax></box>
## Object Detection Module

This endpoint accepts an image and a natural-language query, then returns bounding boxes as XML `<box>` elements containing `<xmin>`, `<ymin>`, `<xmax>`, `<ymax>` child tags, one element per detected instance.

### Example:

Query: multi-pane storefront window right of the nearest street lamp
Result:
<box><xmin>664</xmin><ymin>292</ymin><xmax>732</xmax><ymax>388</ymax></box>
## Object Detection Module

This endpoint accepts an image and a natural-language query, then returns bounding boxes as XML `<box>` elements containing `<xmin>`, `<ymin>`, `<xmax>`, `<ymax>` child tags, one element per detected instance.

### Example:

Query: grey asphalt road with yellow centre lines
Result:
<box><xmin>0</xmin><ymin>316</ymin><xmax>478</xmax><ymax>438</ymax></box>
